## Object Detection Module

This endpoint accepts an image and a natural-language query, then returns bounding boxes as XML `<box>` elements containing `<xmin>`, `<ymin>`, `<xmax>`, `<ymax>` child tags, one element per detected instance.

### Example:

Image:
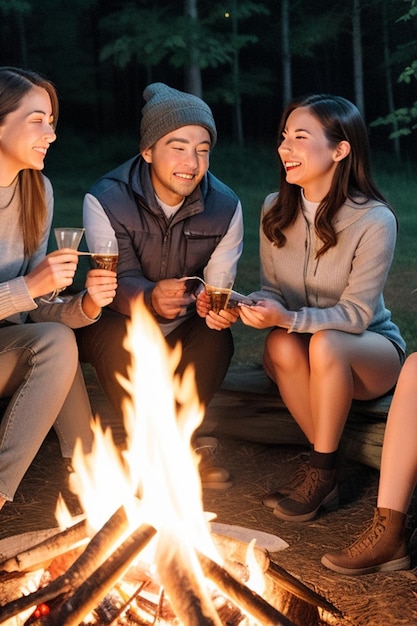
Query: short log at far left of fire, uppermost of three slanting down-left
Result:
<box><xmin>0</xmin><ymin>520</ymin><xmax>88</xmax><ymax>572</ymax></box>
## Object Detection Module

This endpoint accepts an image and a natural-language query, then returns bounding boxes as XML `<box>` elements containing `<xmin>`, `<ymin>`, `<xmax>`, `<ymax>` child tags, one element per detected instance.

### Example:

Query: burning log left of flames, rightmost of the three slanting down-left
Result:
<box><xmin>44</xmin><ymin>524</ymin><xmax>156</xmax><ymax>626</ymax></box>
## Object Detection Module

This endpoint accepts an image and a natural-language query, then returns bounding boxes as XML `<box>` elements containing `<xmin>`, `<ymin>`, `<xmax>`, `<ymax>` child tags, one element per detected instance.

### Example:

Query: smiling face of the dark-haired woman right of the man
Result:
<box><xmin>278</xmin><ymin>107</ymin><xmax>347</xmax><ymax>202</ymax></box>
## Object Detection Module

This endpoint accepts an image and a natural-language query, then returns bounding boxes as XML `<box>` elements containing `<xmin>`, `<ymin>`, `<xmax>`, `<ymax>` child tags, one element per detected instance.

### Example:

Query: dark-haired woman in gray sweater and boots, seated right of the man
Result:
<box><xmin>240</xmin><ymin>95</ymin><xmax>405</xmax><ymax>521</ymax></box>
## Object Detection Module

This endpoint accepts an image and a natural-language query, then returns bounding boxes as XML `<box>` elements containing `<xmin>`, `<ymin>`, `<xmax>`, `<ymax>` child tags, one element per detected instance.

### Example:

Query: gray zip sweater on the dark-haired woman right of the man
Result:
<box><xmin>254</xmin><ymin>193</ymin><xmax>405</xmax><ymax>352</ymax></box>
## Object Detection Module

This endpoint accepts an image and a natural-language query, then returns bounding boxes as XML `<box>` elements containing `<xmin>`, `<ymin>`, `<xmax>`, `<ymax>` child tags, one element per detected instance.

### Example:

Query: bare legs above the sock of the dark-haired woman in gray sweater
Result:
<box><xmin>264</xmin><ymin>329</ymin><xmax>401</xmax><ymax>452</ymax></box>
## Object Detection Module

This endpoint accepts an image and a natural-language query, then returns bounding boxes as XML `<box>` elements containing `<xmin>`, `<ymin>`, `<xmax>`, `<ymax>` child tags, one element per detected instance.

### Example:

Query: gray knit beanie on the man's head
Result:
<box><xmin>139</xmin><ymin>83</ymin><xmax>217</xmax><ymax>152</ymax></box>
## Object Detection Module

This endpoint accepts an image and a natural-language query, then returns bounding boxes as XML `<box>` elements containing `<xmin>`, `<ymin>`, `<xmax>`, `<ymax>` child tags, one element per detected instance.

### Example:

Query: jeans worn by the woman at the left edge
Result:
<box><xmin>0</xmin><ymin>322</ymin><xmax>92</xmax><ymax>501</ymax></box>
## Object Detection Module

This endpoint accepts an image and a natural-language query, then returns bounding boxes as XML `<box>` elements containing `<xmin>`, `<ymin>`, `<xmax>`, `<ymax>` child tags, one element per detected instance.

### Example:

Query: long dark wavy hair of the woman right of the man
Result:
<box><xmin>262</xmin><ymin>95</ymin><xmax>392</xmax><ymax>256</ymax></box>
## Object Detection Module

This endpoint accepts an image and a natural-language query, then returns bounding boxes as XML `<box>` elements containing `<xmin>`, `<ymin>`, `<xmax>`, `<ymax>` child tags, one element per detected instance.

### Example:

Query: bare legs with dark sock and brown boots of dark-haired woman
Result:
<box><xmin>265</xmin><ymin>330</ymin><xmax>401</xmax><ymax>521</ymax></box>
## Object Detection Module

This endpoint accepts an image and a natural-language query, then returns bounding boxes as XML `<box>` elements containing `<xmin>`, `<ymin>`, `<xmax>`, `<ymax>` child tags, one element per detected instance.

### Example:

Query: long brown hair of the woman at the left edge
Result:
<box><xmin>0</xmin><ymin>67</ymin><xmax>59</xmax><ymax>256</ymax></box>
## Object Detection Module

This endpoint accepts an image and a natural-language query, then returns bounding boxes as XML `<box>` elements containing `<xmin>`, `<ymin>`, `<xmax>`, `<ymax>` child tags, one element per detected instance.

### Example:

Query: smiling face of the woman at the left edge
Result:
<box><xmin>0</xmin><ymin>86</ymin><xmax>56</xmax><ymax>186</ymax></box>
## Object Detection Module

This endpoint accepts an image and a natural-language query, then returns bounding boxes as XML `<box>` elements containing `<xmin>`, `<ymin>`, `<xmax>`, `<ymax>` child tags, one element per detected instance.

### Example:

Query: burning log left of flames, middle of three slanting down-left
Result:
<box><xmin>0</xmin><ymin>507</ymin><xmax>128</xmax><ymax>624</ymax></box>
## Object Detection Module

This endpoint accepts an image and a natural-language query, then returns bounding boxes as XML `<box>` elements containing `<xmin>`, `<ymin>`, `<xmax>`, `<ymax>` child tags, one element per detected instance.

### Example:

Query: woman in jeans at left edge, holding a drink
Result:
<box><xmin>0</xmin><ymin>67</ymin><xmax>116</xmax><ymax>508</ymax></box>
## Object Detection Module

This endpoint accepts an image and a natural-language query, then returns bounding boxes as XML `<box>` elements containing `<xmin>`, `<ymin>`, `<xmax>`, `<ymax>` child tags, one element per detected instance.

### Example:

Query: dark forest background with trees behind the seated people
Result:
<box><xmin>0</xmin><ymin>0</ymin><xmax>417</xmax><ymax>362</ymax></box>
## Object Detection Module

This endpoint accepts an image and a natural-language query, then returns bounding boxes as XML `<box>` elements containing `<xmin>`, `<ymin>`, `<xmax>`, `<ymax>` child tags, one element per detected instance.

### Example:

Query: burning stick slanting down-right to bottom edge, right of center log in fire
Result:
<box><xmin>197</xmin><ymin>552</ymin><xmax>296</xmax><ymax>626</ymax></box>
